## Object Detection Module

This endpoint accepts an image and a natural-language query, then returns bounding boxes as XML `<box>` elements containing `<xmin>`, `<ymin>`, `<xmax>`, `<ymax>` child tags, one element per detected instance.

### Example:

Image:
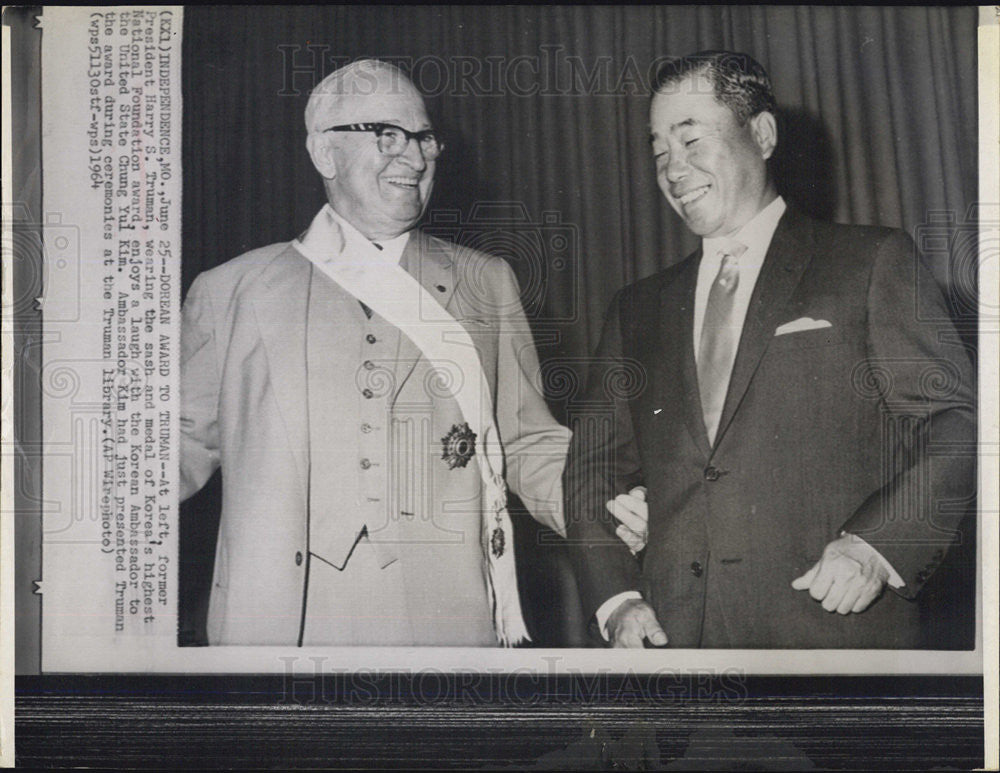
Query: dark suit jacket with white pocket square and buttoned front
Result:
<box><xmin>567</xmin><ymin>211</ymin><xmax>976</xmax><ymax>648</ymax></box>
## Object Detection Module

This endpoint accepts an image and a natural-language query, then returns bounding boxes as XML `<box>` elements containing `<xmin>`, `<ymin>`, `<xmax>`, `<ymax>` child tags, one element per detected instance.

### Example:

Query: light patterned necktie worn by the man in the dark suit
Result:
<box><xmin>698</xmin><ymin>242</ymin><xmax>746</xmax><ymax>443</ymax></box>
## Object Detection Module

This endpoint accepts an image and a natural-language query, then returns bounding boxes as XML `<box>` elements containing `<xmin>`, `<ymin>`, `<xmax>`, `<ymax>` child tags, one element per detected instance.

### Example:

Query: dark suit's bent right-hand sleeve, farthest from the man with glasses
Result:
<box><xmin>843</xmin><ymin>231</ymin><xmax>976</xmax><ymax>598</ymax></box>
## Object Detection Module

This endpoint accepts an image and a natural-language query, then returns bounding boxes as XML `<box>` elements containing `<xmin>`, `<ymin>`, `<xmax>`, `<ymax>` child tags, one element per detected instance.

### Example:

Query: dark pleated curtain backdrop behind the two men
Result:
<box><xmin>182</xmin><ymin>6</ymin><xmax>977</xmax><ymax>643</ymax></box>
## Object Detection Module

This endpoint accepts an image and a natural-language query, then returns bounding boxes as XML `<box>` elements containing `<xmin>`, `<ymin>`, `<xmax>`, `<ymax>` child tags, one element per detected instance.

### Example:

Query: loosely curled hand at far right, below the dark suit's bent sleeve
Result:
<box><xmin>792</xmin><ymin>534</ymin><xmax>889</xmax><ymax>615</ymax></box>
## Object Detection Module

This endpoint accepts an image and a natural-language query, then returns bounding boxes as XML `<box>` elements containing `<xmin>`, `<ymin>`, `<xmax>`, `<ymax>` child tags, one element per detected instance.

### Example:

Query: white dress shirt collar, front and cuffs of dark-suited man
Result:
<box><xmin>594</xmin><ymin>196</ymin><xmax>905</xmax><ymax>639</ymax></box>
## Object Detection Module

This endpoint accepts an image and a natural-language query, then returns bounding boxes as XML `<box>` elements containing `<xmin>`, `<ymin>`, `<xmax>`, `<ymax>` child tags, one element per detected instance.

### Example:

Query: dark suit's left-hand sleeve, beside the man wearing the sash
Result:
<box><xmin>565</xmin><ymin>294</ymin><xmax>642</xmax><ymax>619</ymax></box>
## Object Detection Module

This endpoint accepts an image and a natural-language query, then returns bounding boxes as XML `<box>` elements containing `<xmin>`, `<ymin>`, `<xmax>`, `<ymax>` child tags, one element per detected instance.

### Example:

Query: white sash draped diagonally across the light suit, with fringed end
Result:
<box><xmin>293</xmin><ymin>204</ymin><xmax>530</xmax><ymax>646</ymax></box>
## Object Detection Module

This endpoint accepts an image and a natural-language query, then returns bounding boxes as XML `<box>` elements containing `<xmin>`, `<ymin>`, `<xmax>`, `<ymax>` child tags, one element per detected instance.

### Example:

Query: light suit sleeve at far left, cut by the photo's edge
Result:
<box><xmin>180</xmin><ymin>277</ymin><xmax>226</xmax><ymax>502</ymax></box>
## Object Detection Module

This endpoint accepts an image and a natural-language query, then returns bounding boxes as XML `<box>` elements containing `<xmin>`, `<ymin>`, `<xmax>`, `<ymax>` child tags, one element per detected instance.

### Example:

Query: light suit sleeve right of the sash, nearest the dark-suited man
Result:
<box><xmin>494</xmin><ymin>259</ymin><xmax>571</xmax><ymax>537</ymax></box>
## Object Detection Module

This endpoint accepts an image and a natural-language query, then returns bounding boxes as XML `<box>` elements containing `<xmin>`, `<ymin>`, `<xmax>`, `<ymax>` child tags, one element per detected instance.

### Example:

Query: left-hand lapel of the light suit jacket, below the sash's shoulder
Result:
<box><xmin>253</xmin><ymin>246</ymin><xmax>312</xmax><ymax>489</ymax></box>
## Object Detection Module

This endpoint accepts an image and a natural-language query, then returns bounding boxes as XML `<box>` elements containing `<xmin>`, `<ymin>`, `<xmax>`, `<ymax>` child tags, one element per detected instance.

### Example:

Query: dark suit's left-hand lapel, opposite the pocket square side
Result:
<box><xmin>654</xmin><ymin>248</ymin><xmax>711</xmax><ymax>458</ymax></box>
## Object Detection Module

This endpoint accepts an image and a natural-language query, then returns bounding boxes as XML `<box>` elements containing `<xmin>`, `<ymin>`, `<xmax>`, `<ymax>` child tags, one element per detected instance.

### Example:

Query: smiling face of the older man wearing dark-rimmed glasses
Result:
<box><xmin>307</xmin><ymin>71</ymin><xmax>436</xmax><ymax>240</ymax></box>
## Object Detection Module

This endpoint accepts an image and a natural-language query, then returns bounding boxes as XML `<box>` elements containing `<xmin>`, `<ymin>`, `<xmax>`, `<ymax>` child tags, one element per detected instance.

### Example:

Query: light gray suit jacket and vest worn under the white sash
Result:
<box><xmin>180</xmin><ymin>231</ymin><xmax>570</xmax><ymax>645</ymax></box>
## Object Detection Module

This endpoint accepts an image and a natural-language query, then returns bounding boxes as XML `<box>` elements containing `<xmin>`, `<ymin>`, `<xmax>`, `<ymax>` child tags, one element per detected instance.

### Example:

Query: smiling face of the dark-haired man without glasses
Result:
<box><xmin>649</xmin><ymin>73</ymin><xmax>777</xmax><ymax>238</ymax></box>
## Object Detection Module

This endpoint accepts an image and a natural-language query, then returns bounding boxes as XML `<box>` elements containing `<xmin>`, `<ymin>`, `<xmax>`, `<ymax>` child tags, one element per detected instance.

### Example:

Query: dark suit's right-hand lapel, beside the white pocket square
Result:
<box><xmin>715</xmin><ymin>211</ymin><xmax>812</xmax><ymax>447</ymax></box>
